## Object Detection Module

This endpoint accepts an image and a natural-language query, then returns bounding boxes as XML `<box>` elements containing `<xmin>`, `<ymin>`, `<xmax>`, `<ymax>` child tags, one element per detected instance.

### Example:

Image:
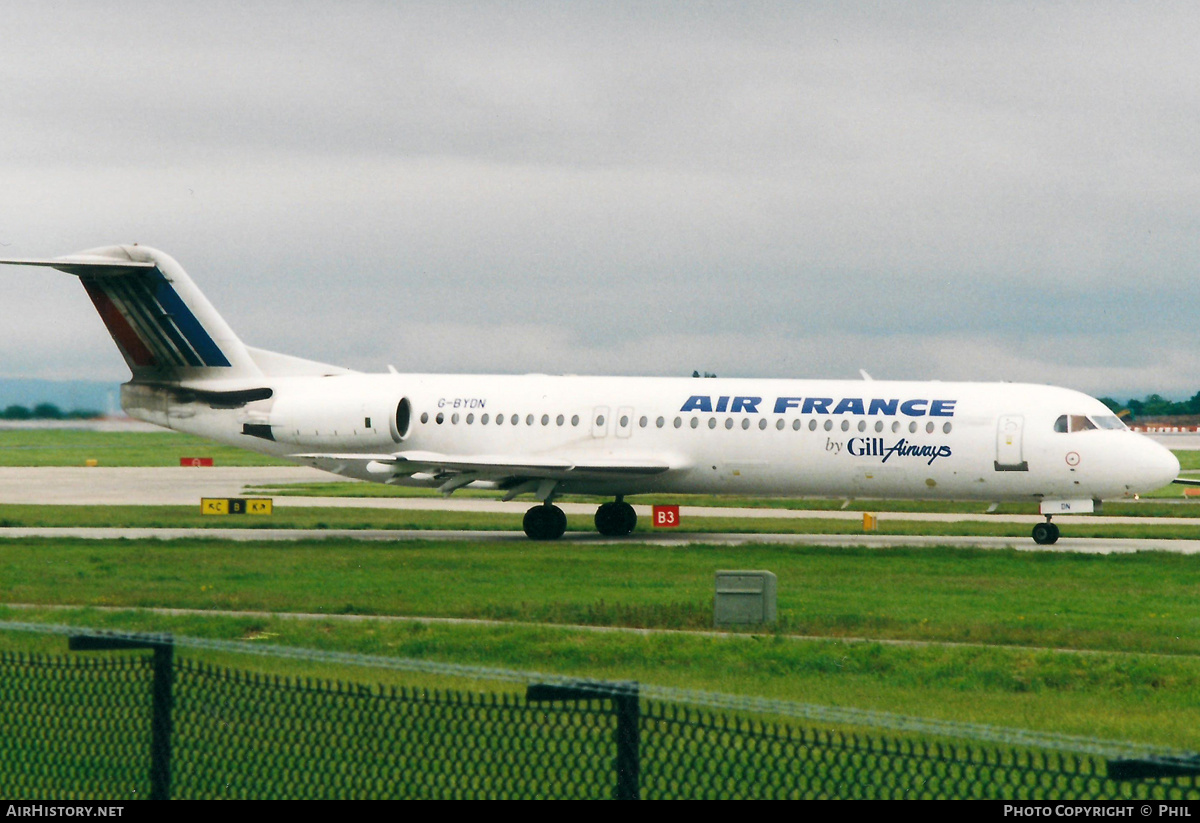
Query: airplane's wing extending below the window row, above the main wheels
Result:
<box><xmin>292</xmin><ymin>451</ymin><xmax>672</xmax><ymax>499</ymax></box>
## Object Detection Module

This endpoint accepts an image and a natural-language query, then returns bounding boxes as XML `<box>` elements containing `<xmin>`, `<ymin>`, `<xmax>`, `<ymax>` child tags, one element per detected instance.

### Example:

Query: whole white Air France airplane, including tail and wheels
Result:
<box><xmin>0</xmin><ymin>245</ymin><xmax>1180</xmax><ymax>543</ymax></box>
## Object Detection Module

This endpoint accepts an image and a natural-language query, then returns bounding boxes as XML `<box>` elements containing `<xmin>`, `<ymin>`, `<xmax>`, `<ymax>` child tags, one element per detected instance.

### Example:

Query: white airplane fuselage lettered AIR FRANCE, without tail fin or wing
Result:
<box><xmin>124</xmin><ymin>373</ymin><xmax>1176</xmax><ymax>500</ymax></box>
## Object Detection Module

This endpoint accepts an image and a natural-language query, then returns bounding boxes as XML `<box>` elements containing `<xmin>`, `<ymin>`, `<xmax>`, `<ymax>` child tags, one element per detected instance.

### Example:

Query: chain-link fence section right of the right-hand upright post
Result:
<box><xmin>642</xmin><ymin>704</ymin><xmax>1200</xmax><ymax>800</ymax></box>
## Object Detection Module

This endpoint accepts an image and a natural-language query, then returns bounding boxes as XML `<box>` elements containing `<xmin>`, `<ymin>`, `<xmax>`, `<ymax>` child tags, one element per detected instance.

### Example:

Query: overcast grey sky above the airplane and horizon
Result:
<box><xmin>0</xmin><ymin>0</ymin><xmax>1200</xmax><ymax>398</ymax></box>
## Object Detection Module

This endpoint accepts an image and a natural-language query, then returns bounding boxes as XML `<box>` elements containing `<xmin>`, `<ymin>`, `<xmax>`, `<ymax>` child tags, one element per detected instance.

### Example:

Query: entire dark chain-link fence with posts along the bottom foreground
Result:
<box><xmin>0</xmin><ymin>632</ymin><xmax>1200</xmax><ymax>800</ymax></box>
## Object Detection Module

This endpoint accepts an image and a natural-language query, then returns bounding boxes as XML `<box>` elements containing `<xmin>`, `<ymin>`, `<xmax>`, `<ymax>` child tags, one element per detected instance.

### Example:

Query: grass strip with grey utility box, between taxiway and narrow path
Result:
<box><xmin>0</xmin><ymin>540</ymin><xmax>1200</xmax><ymax>655</ymax></box>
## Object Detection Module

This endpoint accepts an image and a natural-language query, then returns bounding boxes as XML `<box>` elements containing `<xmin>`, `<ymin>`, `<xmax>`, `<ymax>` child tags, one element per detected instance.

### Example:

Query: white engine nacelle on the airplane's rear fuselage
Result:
<box><xmin>261</xmin><ymin>390</ymin><xmax>413</xmax><ymax>451</ymax></box>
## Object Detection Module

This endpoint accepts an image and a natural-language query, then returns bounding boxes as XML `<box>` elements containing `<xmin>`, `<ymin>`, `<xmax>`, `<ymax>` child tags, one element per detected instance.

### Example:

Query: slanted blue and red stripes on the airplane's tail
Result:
<box><xmin>82</xmin><ymin>269</ymin><xmax>229</xmax><ymax>368</ymax></box>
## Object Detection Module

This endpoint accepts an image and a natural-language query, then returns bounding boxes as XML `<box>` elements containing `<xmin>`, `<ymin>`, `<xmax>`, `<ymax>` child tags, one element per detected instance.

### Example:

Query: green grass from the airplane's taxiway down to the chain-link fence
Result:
<box><xmin>0</xmin><ymin>540</ymin><xmax>1200</xmax><ymax>749</ymax></box>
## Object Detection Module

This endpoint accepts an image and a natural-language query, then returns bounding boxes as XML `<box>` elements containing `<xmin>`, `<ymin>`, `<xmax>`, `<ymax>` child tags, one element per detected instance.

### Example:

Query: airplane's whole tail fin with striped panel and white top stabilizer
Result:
<box><xmin>0</xmin><ymin>245</ymin><xmax>263</xmax><ymax>383</ymax></box>
